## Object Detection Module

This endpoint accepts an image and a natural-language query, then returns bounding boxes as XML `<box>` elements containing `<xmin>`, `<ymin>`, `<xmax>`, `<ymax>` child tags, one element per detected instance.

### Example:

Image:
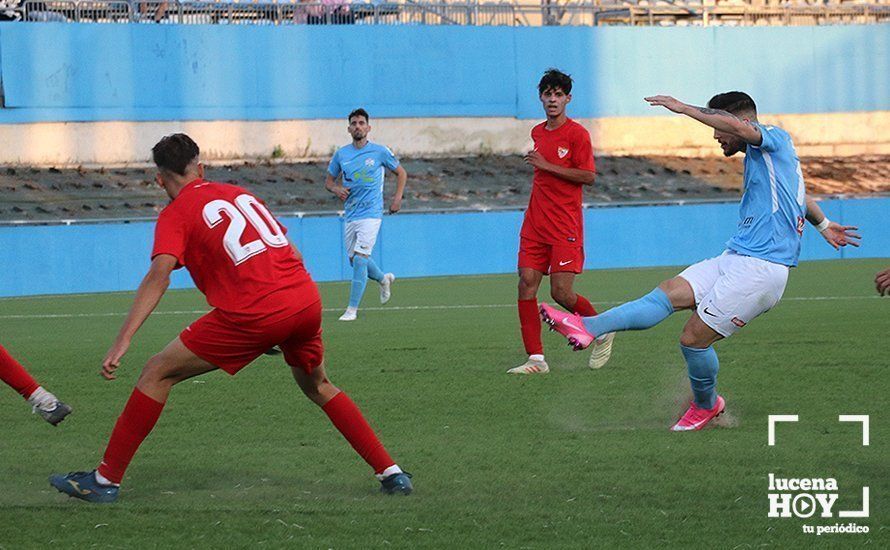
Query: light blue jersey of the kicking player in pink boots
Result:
<box><xmin>726</xmin><ymin>125</ymin><xmax>807</xmax><ymax>272</ymax></box>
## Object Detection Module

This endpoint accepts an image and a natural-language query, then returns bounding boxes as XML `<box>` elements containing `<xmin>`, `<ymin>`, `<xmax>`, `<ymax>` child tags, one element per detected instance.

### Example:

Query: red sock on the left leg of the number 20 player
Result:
<box><xmin>99</xmin><ymin>388</ymin><xmax>164</xmax><ymax>483</ymax></box>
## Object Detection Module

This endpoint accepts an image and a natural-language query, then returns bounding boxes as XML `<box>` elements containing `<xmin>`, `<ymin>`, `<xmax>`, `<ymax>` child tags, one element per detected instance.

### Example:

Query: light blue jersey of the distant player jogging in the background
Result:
<box><xmin>328</xmin><ymin>142</ymin><xmax>399</xmax><ymax>222</ymax></box>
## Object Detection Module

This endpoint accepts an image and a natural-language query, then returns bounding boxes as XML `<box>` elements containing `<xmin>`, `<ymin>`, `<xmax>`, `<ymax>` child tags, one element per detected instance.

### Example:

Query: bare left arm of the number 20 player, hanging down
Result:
<box><xmin>102</xmin><ymin>254</ymin><xmax>176</xmax><ymax>380</ymax></box>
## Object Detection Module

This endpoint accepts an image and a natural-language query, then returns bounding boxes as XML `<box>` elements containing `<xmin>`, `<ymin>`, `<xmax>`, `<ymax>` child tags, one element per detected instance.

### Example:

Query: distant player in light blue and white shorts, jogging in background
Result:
<box><xmin>324</xmin><ymin>109</ymin><xmax>408</xmax><ymax>321</ymax></box>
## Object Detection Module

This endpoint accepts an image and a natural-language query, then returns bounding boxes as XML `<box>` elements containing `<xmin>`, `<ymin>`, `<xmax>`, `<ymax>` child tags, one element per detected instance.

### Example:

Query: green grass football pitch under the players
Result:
<box><xmin>0</xmin><ymin>261</ymin><xmax>890</xmax><ymax>548</ymax></box>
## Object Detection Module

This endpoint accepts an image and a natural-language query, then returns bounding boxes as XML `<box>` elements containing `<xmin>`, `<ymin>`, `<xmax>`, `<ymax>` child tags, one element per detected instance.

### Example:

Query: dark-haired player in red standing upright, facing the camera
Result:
<box><xmin>507</xmin><ymin>69</ymin><xmax>612</xmax><ymax>374</ymax></box>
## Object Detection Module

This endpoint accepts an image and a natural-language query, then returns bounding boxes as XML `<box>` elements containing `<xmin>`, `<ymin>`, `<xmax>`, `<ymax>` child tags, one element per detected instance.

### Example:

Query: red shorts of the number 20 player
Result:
<box><xmin>179</xmin><ymin>301</ymin><xmax>324</xmax><ymax>374</ymax></box>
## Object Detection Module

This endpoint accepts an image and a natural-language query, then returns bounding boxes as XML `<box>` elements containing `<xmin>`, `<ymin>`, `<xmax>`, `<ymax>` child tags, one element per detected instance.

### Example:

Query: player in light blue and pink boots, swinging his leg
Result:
<box><xmin>541</xmin><ymin>92</ymin><xmax>859</xmax><ymax>432</ymax></box>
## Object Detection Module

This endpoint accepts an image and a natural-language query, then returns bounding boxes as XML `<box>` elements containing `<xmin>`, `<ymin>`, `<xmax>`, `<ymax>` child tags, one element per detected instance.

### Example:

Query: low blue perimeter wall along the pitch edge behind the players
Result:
<box><xmin>0</xmin><ymin>198</ymin><xmax>890</xmax><ymax>296</ymax></box>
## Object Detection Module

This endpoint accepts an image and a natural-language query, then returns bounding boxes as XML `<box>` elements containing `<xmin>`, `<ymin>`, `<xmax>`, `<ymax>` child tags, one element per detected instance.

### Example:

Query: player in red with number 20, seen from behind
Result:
<box><xmin>50</xmin><ymin>134</ymin><xmax>412</xmax><ymax>502</ymax></box>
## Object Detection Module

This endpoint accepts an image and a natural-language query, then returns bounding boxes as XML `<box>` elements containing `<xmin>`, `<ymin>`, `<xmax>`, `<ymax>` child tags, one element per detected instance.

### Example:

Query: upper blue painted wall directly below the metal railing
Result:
<box><xmin>0</xmin><ymin>23</ymin><xmax>890</xmax><ymax>124</ymax></box>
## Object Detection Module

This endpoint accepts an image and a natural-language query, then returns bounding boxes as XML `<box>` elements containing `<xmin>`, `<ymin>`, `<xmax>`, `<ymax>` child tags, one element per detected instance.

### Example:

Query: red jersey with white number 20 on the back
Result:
<box><xmin>151</xmin><ymin>180</ymin><xmax>320</xmax><ymax>322</ymax></box>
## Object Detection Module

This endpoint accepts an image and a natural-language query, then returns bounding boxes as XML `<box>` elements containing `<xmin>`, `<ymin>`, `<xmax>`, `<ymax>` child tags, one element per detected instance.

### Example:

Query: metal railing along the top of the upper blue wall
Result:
<box><xmin>6</xmin><ymin>0</ymin><xmax>890</xmax><ymax>26</ymax></box>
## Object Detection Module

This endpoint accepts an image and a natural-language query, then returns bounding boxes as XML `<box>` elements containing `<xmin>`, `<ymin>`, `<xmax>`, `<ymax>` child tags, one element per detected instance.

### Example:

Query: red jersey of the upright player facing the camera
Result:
<box><xmin>520</xmin><ymin>119</ymin><xmax>595</xmax><ymax>246</ymax></box>
